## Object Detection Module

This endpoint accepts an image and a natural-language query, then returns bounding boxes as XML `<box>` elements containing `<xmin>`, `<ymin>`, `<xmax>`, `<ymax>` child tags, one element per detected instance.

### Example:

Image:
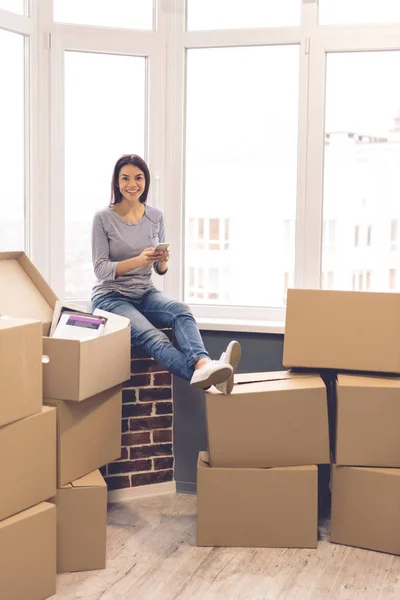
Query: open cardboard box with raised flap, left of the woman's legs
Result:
<box><xmin>0</xmin><ymin>252</ymin><xmax>131</xmax><ymax>401</ymax></box>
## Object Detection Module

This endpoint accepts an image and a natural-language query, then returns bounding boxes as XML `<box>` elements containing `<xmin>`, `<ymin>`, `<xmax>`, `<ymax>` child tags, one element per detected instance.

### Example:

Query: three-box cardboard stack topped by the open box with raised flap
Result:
<box><xmin>0</xmin><ymin>252</ymin><xmax>130</xmax><ymax>572</ymax></box>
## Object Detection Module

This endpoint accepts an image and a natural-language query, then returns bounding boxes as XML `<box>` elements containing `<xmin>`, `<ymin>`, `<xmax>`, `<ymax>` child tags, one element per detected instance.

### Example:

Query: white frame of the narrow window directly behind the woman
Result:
<box><xmin>50</xmin><ymin>23</ymin><xmax>165</xmax><ymax>301</ymax></box>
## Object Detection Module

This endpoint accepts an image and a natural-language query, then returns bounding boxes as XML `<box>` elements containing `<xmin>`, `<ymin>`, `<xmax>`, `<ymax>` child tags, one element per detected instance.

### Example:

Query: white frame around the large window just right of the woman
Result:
<box><xmin>162</xmin><ymin>0</ymin><xmax>317</xmax><ymax>323</ymax></box>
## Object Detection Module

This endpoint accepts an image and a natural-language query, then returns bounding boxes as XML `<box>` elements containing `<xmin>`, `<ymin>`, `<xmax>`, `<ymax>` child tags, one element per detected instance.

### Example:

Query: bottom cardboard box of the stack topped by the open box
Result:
<box><xmin>52</xmin><ymin>471</ymin><xmax>107</xmax><ymax>573</ymax></box>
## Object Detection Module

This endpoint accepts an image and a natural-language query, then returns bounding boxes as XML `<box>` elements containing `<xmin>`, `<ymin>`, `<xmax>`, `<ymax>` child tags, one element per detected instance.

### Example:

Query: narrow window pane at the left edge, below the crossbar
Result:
<box><xmin>0</xmin><ymin>29</ymin><xmax>25</xmax><ymax>251</ymax></box>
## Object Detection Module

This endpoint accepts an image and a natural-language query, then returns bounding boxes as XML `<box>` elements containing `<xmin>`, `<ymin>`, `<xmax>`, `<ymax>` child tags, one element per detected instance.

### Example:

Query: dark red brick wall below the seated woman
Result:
<box><xmin>101</xmin><ymin>330</ymin><xmax>174</xmax><ymax>490</ymax></box>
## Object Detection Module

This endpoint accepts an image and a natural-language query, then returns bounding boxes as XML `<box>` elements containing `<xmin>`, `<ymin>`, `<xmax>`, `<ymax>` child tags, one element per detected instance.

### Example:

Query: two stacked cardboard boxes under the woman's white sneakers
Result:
<box><xmin>197</xmin><ymin>372</ymin><xmax>329</xmax><ymax>548</ymax></box>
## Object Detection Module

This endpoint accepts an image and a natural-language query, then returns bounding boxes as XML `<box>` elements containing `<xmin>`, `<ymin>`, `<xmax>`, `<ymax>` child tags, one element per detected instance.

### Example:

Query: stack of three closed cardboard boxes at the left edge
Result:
<box><xmin>0</xmin><ymin>317</ymin><xmax>56</xmax><ymax>600</ymax></box>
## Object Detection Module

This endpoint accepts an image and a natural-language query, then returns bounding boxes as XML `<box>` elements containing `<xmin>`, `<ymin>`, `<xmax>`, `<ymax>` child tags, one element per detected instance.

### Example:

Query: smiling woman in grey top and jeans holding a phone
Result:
<box><xmin>92</xmin><ymin>154</ymin><xmax>241</xmax><ymax>394</ymax></box>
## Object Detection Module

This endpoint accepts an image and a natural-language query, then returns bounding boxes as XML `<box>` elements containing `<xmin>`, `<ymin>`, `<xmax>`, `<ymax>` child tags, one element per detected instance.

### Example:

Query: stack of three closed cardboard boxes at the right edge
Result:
<box><xmin>283</xmin><ymin>290</ymin><xmax>400</xmax><ymax>554</ymax></box>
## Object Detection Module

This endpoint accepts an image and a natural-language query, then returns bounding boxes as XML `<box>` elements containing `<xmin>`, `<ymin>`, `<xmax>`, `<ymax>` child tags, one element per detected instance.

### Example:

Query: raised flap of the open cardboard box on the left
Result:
<box><xmin>0</xmin><ymin>252</ymin><xmax>57</xmax><ymax>325</ymax></box>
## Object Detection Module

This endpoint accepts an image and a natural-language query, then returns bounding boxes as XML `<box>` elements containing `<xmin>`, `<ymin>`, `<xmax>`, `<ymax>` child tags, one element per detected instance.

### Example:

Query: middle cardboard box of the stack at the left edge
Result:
<box><xmin>0</xmin><ymin>407</ymin><xmax>56</xmax><ymax>520</ymax></box>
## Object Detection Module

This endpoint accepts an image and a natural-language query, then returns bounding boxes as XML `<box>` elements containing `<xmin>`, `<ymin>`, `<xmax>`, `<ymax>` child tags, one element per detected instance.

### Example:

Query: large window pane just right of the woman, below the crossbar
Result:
<box><xmin>185</xmin><ymin>46</ymin><xmax>299</xmax><ymax>307</ymax></box>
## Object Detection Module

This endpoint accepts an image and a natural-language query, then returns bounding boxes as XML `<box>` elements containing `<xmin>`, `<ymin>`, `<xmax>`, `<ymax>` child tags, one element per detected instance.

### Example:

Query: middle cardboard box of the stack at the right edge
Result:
<box><xmin>335</xmin><ymin>375</ymin><xmax>400</xmax><ymax>467</ymax></box>
